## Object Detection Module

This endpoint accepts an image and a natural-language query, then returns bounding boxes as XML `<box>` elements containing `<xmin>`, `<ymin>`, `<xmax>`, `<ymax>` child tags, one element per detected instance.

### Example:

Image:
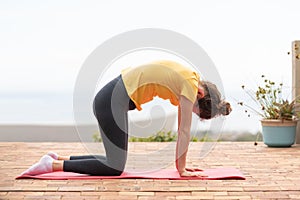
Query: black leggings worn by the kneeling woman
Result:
<box><xmin>63</xmin><ymin>75</ymin><xmax>135</xmax><ymax>176</ymax></box>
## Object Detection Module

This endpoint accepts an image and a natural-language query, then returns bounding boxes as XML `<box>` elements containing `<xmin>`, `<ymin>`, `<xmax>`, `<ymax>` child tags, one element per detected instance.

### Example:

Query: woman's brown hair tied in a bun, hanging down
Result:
<box><xmin>198</xmin><ymin>81</ymin><xmax>232</xmax><ymax>119</ymax></box>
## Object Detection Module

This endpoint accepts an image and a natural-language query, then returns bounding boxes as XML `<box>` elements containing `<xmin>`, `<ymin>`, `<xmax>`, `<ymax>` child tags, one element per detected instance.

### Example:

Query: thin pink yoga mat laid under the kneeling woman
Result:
<box><xmin>17</xmin><ymin>168</ymin><xmax>246</xmax><ymax>180</ymax></box>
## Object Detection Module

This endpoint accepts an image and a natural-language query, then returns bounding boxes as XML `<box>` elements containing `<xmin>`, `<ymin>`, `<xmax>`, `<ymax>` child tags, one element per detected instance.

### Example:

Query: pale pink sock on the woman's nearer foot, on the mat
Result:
<box><xmin>21</xmin><ymin>155</ymin><xmax>54</xmax><ymax>175</ymax></box>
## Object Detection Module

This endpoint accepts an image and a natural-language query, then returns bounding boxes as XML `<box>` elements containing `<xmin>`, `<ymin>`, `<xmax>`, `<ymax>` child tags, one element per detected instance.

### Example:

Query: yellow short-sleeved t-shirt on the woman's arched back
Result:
<box><xmin>121</xmin><ymin>61</ymin><xmax>199</xmax><ymax>110</ymax></box>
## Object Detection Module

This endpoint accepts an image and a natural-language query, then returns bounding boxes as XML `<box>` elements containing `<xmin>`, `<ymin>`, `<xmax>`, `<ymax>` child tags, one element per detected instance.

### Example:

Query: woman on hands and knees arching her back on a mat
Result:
<box><xmin>23</xmin><ymin>61</ymin><xmax>231</xmax><ymax>176</ymax></box>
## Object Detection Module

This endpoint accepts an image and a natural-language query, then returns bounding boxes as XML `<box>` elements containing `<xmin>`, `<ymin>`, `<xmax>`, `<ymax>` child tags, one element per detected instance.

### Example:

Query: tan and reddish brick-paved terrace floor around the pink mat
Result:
<box><xmin>0</xmin><ymin>142</ymin><xmax>300</xmax><ymax>200</ymax></box>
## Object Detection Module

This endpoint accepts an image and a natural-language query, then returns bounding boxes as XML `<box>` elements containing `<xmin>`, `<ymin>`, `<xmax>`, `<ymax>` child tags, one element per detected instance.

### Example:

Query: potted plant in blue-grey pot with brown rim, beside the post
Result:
<box><xmin>238</xmin><ymin>75</ymin><xmax>299</xmax><ymax>147</ymax></box>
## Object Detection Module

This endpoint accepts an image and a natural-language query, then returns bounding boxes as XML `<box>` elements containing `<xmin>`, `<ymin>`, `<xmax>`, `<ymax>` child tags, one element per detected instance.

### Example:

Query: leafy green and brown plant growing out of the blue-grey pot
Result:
<box><xmin>238</xmin><ymin>75</ymin><xmax>299</xmax><ymax>120</ymax></box>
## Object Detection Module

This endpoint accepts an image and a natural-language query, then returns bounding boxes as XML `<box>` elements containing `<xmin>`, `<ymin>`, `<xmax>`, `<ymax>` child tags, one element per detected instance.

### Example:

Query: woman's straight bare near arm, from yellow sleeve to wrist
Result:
<box><xmin>176</xmin><ymin>96</ymin><xmax>193</xmax><ymax>174</ymax></box>
